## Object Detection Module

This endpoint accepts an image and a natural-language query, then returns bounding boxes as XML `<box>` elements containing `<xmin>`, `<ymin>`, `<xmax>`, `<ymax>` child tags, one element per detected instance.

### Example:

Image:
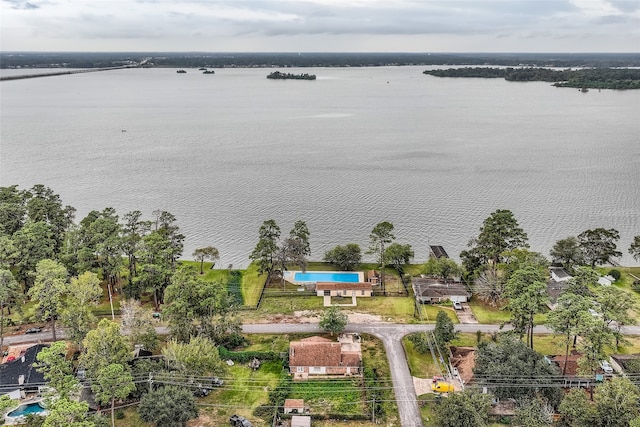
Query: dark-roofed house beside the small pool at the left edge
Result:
<box><xmin>0</xmin><ymin>344</ymin><xmax>47</xmax><ymax>398</ymax></box>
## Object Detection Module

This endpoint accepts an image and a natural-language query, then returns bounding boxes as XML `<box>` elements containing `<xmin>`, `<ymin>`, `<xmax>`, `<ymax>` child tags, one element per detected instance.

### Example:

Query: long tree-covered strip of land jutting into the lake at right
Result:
<box><xmin>423</xmin><ymin>67</ymin><xmax>640</xmax><ymax>89</ymax></box>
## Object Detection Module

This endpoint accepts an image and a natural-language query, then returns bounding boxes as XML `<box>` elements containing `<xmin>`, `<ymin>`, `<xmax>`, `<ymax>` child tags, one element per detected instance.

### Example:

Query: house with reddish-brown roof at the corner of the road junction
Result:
<box><xmin>289</xmin><ymin>334</ymin><xmax>362</xmax><ymax>379</ymax></box>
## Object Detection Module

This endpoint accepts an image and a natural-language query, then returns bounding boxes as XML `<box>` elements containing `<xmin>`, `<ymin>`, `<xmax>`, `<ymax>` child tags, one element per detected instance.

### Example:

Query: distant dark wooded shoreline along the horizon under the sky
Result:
<box><xmin>0</xmin><ymin>52</ymin><xmax>640</xmax><ymax>69</ymax></box>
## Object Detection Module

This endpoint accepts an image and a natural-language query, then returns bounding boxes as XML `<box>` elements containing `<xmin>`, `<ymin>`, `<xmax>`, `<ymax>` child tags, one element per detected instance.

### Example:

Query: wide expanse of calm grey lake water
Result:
<box><xmin>0</xmin><ymin>67</ymin><xmax>640</xmax><ymax>267</ymax></box>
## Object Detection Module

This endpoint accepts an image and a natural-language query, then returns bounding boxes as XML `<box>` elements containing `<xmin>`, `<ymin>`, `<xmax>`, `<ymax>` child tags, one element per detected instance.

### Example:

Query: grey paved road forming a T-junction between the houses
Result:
<box><xmin>4</xmin><ymin>323</ymin><xmax>640</xmax><ymax>427</ymax></box>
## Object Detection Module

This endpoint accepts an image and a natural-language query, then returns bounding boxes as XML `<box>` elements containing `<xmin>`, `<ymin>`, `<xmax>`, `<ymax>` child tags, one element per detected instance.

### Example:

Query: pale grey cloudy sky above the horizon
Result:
<box><xmin>0</xmin><ymin>0</ymin><xmax>640</xmax><ymax>52</ymax></box>
